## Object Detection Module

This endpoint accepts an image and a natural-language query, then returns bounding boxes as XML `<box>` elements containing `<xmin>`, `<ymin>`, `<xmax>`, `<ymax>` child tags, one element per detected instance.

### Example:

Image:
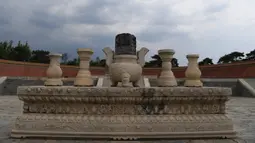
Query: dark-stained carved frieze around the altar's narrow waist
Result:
<box><xmin>23</xmin><ymin>103</ymin><xmax>224</xmax><ymax>115</ymax></box>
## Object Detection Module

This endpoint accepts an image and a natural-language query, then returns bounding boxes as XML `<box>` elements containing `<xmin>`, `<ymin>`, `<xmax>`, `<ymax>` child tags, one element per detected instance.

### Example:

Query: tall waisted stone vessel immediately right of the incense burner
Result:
<box><xmin>158</xmin><ymin>49</ymin><xmax>177</xmax><ymax>87</ymax></box>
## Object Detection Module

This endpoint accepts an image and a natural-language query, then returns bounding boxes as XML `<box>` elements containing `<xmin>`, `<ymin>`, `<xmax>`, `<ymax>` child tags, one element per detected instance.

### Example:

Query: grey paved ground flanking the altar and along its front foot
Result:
<box><xmin>0</xmin><ymin>95</ymin><xmax>255</xmax><ymax>143</ymax></box>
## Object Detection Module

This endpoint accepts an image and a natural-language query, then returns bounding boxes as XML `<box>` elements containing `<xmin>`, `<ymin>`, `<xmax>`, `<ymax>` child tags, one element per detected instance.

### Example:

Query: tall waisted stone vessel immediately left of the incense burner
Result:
<box><xmin>74</xmin><ymin>48</ymin><xmax>93</xmax><ymax>86</ymax></box>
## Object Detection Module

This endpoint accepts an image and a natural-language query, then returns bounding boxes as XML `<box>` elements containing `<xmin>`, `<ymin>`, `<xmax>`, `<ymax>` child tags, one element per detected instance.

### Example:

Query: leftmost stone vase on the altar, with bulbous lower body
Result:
<box><xmin>44</xmin><ymin>54</ymin><xmax>63</xmax><ymax>86</ymax></box>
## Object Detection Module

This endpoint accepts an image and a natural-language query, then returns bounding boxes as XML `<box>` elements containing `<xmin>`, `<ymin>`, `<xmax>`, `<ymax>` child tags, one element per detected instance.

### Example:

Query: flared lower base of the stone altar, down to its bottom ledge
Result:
<box><xmin>11</xmin><ymin>113</ymin><xmax>236</xmax><ymax>140</ymax></box>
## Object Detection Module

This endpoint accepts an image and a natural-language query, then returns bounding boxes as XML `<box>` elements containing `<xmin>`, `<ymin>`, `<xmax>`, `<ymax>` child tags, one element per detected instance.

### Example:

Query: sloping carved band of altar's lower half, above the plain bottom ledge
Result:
<box><xmin>15</xmin><ymin>114</ymin><xmax>233</xmax><ymax>132</ymax></box>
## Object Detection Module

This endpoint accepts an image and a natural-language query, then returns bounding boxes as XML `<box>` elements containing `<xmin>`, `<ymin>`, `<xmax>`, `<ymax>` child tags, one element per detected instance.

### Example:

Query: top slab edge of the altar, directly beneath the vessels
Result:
<box><xmin>17</xmin><ymin>86</ymin><xmax>232</xmax><ymax>97</ymax></box>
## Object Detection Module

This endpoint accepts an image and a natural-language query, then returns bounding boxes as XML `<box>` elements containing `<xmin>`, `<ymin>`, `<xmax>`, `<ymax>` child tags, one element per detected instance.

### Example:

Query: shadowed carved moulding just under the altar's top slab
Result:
<box><xmin>19</xmin><ymin>94</ymin><xmax>227</xmax><ymax>104</ymax></box>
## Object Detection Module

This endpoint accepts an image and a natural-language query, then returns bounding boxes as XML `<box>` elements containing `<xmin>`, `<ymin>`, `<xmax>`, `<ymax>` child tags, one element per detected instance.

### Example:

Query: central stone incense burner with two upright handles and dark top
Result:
<box><xmin>103</xmin><ymin>33</ymin><xmax>149</xmax><ymax>87</ymax></box>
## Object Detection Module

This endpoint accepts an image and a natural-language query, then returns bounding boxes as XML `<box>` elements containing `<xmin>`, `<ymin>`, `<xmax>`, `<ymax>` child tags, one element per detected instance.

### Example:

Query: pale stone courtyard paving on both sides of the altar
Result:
<box><xmin>0</xmin><ymin>96</ymin><xmax>255</xmax><ymax>143</ymax></box>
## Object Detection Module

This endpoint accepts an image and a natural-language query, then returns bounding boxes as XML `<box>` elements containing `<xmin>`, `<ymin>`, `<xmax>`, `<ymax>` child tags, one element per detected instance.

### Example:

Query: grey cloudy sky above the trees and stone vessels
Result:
<box><xmin>0</xmin><ymin>0</ymin><xmax>255</xmax><ymax>65</ymax></box>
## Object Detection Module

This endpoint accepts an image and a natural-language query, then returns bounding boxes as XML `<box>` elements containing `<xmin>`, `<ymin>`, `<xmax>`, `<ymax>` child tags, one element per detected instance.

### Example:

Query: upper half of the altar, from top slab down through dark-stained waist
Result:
<box><xmin>18</xmin><ymin>86</ymin><xmax>231</xmax><ymax>115</ymax></box>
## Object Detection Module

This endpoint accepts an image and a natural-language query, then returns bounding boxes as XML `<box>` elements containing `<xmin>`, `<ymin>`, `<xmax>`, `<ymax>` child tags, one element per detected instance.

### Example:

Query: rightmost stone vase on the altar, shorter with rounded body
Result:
<box><xmin>184</xmin><ymin>54</ymin><xmax>203</xmax><ymax>87</ymax></box>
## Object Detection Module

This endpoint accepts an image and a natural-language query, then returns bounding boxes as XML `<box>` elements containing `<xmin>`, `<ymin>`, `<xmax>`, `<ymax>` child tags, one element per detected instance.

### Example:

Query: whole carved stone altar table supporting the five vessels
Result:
<box><xmin>11</xmin><ymin>33</ymin><xmax>236</xmax><ymax>143</ymax></box>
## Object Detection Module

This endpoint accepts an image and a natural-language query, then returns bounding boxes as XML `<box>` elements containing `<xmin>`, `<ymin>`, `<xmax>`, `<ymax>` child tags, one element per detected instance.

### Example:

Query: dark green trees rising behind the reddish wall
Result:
<box><xmin>0</xmin><ymin>41</ymin><xmax>255</xmax><ymax>67</ymax></box>
